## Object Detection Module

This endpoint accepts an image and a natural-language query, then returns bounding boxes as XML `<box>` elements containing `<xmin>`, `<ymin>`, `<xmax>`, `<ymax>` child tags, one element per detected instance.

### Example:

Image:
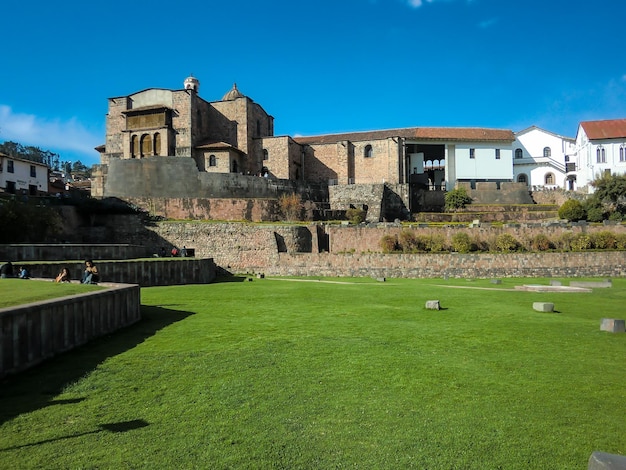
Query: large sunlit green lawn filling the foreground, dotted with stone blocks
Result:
<box><xmin>0</xmin><ymin>279</ymin><xmax>626</xmax><ymax>469</ymax></box>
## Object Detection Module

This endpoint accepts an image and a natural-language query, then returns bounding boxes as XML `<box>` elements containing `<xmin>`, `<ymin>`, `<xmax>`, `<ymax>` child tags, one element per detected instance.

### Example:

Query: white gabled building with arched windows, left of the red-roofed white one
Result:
<box><xmin>513</xmin><ymin>126</ymin><xmax>576</xmax><ymax>190</ymax></box>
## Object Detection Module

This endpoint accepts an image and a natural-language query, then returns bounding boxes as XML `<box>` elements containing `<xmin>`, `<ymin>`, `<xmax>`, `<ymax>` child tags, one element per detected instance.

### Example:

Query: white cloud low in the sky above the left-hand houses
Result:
<box><xmin>0</xmin><ymin>104</ymin><xmax>103</xmax><ymax>158</ymax></box>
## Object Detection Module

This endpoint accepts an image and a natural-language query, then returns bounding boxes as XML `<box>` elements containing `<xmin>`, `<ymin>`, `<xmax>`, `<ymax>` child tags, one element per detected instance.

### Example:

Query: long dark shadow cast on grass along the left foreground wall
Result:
<box><xmin>0</xmin><ymin>305</ymin><xmax>193</xmax><ymax>424</ymax></box>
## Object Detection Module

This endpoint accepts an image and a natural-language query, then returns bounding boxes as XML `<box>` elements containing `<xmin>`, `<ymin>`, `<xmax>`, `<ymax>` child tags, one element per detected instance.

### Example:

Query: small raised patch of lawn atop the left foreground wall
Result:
<box><xmin>0</xmin><ymin>279</ymin><xmax>102</xmax><ymax>308</ymax></box>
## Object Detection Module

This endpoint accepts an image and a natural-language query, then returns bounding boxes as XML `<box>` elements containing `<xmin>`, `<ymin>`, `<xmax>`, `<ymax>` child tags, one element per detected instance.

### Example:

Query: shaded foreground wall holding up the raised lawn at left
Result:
<box><xmin>0</xmin><ymin>281</ymin><xmax>141</xmax><ymax>378</ymax></box>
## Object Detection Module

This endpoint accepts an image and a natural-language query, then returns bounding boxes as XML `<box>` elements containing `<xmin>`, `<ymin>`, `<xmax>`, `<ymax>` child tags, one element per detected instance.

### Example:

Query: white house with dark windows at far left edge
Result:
<box><xmin>0</xmin><ymin>153</ymin><xmax>48</xmax><ymax>196</ymax></box>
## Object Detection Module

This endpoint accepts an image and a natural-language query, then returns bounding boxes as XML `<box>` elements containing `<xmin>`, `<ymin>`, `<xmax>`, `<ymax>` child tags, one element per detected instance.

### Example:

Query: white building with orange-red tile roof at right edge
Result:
<box><xmin>572</xmin><ymin>119</ymin><xmax>626</xmax><ymax>192</ymax></box>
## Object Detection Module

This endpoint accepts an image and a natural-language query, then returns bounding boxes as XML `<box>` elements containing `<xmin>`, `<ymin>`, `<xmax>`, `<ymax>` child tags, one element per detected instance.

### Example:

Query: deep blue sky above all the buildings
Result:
<box><xmin>0</xmin><ymin>0</ymin><xmax>626</xmax><ymax>165</ymax></box>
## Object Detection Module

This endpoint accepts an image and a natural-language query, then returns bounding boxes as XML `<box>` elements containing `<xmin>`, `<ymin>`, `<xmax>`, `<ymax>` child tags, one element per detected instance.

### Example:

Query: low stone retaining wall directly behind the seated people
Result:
<box><xmin>20</xmin><ymin>258</ymin><xmax>217</xmax><ymax>287</ymax></box>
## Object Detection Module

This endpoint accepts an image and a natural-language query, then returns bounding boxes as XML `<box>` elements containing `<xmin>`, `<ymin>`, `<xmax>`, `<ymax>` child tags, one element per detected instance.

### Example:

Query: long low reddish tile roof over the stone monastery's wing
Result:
<box><xmin>294</xmin><ymin>127</ymin><xmax>515</xmax><ymax>144</ymax></box>
